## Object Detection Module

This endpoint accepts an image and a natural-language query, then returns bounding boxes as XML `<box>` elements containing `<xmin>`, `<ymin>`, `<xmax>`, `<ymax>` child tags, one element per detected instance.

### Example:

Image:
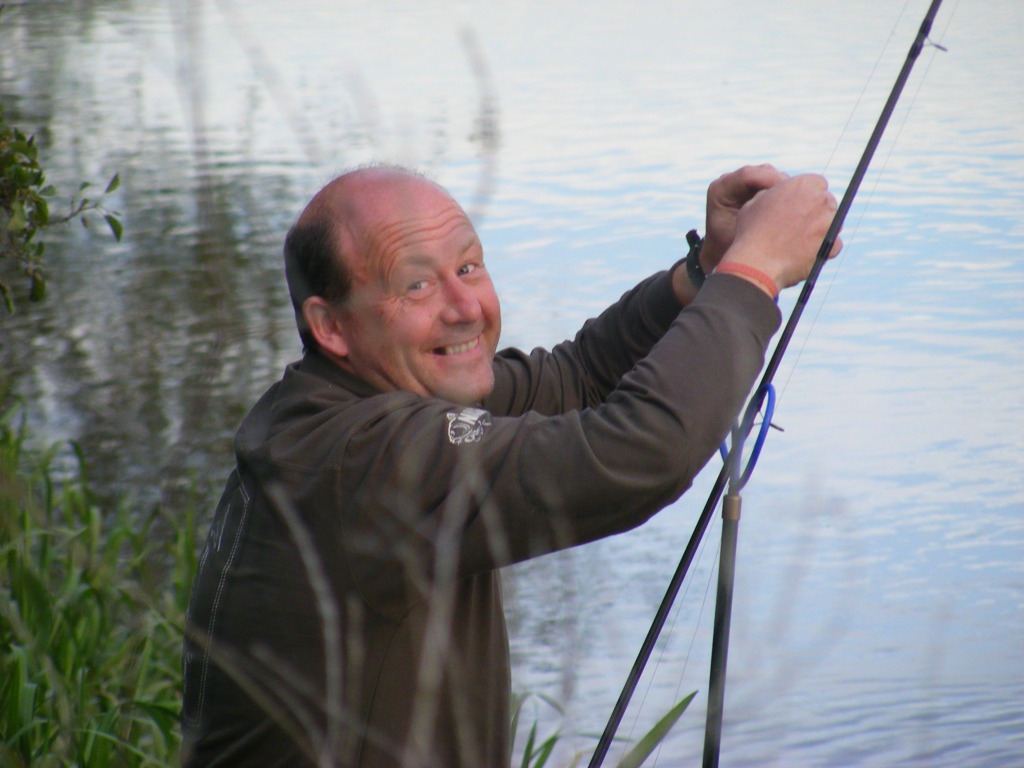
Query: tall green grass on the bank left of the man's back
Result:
<box><xmin>0</xmin><ymin>408</ymin><xmax>186</xmax><ymax>768</ymax></box>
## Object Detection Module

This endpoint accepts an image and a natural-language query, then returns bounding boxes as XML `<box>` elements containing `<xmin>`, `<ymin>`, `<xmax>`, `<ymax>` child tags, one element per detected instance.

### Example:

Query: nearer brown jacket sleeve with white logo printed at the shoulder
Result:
<box><xmin>335</xmin><ymin>275</ymin><xmax>779</xmax><ymax>614</ymax></box>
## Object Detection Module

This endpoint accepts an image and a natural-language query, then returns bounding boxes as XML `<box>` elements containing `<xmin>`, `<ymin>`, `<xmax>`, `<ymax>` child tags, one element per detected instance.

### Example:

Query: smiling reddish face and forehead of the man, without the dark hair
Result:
<box><xmin>338</xmin><ymin>177</ymin><xmax>501</xmax><ymax>404</ymax></box>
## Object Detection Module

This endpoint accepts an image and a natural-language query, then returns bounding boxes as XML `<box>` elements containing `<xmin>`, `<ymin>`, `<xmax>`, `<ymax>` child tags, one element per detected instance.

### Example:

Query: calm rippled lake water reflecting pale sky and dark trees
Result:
<box><xmin>0</xmin><ymin>0</ymin><xmax>1024</xmax><ymax>766</ymax></box>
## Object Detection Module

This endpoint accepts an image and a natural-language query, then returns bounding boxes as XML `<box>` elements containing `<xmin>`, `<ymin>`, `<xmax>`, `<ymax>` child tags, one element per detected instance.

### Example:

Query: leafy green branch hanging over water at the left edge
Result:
<box><xmin>0</xmin><ymin>104</ymin><xmax>124</xmax><ymax>312</ymax></box>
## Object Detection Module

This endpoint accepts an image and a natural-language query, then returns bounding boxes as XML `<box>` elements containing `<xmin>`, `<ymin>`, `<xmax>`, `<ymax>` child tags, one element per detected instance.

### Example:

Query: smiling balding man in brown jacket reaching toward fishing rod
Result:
<box><xmin>182</xmin><ymin>160</ymin><xmax>841</xmax><ymax>768</ymax></box>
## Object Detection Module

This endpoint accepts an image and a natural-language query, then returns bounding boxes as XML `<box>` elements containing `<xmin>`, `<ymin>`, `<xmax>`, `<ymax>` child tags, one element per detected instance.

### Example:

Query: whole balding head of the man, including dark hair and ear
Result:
<box><xmin>285</xmin><ymin>162</ymin><xmax>501</xmax><ymax>404</ymax></box>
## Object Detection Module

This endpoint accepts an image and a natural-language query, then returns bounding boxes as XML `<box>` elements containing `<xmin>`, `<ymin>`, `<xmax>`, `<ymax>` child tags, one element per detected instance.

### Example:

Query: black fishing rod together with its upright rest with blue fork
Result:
<box><xmin>589</xmin><ymin>0</ymin><xmax>945</xmax><ymax>768</ymax></box>
